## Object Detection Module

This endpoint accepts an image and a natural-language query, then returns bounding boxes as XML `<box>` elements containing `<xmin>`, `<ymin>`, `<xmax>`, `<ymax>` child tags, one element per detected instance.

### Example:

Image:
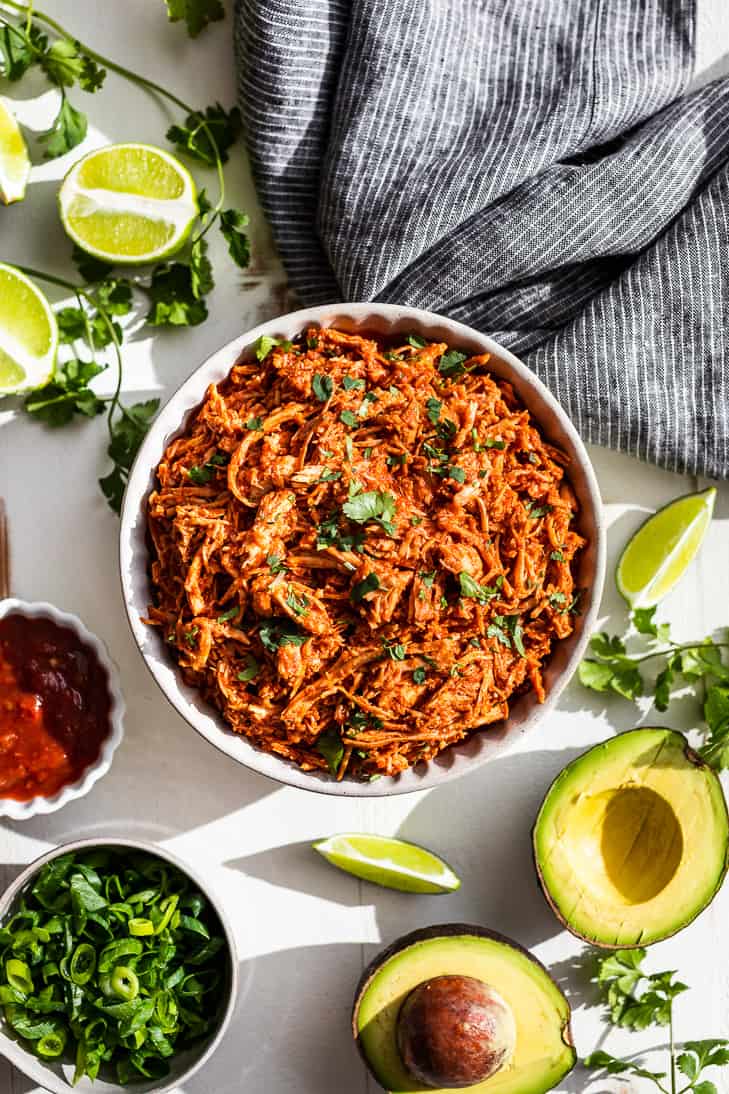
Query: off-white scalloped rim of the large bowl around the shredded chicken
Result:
<box><xmin>119</xmin><ymin>304</ymin><xmax>605</xmax><ymax>798</ymax></box>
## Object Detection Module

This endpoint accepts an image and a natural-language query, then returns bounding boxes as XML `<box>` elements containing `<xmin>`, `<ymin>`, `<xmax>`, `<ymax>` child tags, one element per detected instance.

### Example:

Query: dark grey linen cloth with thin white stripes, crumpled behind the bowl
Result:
<box><xmin>236</xmin><ymin>0</ymin><xmax>729</xmax><ymax>477</ymax></box>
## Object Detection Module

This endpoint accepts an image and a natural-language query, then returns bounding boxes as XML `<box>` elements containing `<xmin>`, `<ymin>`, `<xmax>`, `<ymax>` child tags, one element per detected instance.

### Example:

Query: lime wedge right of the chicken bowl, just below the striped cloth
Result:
<box><xmin>615</xmin><ymin>487</ymin><xmax>716</xmax><ymax>608</ymax></box>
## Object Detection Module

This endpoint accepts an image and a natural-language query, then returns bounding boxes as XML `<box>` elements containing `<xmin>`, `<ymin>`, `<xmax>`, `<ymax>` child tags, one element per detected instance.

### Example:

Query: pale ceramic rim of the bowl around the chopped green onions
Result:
<box><xmin>0</xmin><ymin>838</ymin><xmax>239</xmax><ymax>1094</ymax></box>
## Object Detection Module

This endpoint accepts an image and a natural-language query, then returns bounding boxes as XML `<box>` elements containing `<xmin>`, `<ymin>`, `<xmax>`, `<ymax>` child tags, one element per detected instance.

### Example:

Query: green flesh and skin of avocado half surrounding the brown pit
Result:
<box><xmin>352</xmin><ymin>923</ymin><xmax>577</xmax><ymax>1094</ymax></box>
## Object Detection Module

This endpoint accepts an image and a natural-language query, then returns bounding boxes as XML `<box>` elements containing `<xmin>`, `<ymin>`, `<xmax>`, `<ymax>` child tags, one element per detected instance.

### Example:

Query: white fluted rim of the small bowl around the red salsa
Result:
<box><xmin>0</xmin><ymin>596</ymin><xmax>124</xmax><ymax>821</ymax></box>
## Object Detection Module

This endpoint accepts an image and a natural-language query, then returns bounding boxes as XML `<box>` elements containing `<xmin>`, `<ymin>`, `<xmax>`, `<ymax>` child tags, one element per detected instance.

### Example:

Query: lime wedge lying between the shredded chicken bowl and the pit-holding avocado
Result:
<box><xmin>312</xmin><ymin>833</ymin><xmax>461</xmax><ymax>893</ymax></box>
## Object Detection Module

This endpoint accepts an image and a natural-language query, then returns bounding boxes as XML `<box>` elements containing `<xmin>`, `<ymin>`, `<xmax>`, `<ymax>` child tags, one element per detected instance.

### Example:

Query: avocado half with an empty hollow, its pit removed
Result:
<box><xmin>533</xmin><ymin>729</ymin><xmax>729</xmax><ymax>950</ymax></box>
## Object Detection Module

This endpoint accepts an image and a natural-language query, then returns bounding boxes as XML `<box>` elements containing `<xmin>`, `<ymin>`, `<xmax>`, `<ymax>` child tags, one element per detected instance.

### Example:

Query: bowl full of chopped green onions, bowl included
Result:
<box><xmin>0</xmin><ymin>839</ymin><xmax>238</xmax><ymax>1094</ymax></box>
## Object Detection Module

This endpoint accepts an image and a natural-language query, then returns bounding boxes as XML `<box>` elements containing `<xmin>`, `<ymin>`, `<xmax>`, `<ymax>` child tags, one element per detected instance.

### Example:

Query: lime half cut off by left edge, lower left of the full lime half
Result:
<box><xmin>0</xmin><ymin>263</ymin><xmax>58</xmax><ymax>395</ymax></box>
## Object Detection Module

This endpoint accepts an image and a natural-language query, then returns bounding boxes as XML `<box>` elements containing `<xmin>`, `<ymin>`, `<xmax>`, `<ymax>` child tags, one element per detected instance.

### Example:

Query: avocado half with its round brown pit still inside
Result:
<box><xmin>352</xmin><ymin>923</ymin><xmax>576</xmax><ymax>1094</ymax></box>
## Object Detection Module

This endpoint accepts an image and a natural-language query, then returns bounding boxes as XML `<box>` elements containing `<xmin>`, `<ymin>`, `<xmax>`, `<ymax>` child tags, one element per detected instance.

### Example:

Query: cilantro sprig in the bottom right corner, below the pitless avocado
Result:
<box><xmin>583</xmin><ymin>948</ymin><xmax>729</xmax><ymax>1094</ymax></box>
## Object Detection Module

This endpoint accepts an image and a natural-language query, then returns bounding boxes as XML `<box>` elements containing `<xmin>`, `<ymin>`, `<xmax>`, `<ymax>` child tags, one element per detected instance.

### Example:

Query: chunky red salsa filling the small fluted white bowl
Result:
<box><xmin>0</xmin><ymin>613</ymin><xmax>111</xmax><ymax>802</ymax></box>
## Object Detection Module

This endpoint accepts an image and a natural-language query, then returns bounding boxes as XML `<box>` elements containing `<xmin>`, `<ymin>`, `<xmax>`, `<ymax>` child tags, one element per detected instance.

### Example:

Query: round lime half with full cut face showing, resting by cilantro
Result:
<box><xmin>58</xmin><ymin>144</ymin><xmax>198</xmax><ymax>265</ymax></box>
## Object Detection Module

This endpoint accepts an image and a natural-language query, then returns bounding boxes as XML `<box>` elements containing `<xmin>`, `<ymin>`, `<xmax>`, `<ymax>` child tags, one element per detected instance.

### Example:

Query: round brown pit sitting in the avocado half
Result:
<box><xmin>397</xmin><ymin>976</ymin><xmax>517</xmax><ymax>1090</ymax></box>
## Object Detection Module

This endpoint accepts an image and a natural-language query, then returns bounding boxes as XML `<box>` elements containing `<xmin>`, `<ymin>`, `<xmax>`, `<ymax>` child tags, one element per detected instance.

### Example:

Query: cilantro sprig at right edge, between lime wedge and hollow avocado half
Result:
<box><xmin>578</xmin><ymin>607</ymin><xmax>729</xmax><ymax>769</ymax></box>
